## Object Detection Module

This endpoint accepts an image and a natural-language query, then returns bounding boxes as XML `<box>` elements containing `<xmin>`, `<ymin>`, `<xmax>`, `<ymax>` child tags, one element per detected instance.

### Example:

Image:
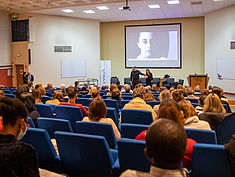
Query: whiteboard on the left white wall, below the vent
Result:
<box><xmin>61</xmin><ymin>60</ymin><xmax>86</xmax><ymax>77</ymax></box>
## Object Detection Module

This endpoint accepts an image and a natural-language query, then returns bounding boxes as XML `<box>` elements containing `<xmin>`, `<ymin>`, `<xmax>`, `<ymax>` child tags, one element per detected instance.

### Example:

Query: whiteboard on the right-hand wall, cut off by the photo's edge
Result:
<box><xmin>216</xmin><ymin>58</ymin><xmax>235</xmax><ymax>80</ymax></box>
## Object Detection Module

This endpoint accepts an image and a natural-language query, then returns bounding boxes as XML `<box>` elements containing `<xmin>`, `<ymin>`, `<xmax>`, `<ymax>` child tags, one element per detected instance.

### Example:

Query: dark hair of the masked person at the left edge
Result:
<box><xmin>0</xmin><ymin>97</ymin><xmax>28</xmax><ymax>126</ymax></box>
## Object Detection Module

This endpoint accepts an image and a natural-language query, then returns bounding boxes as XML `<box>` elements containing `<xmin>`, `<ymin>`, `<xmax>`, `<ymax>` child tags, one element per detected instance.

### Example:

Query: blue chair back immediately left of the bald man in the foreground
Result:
<box><xmin>118</xmin><ymin>138</ymin><xmax>151</xmax><ymax>172</ymax></box>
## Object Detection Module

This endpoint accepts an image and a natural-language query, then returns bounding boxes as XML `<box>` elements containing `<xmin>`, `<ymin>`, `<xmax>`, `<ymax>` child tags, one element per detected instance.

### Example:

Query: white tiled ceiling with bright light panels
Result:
<box><xmin>0</xmin><ymin>0</ymin><xmax>235</xmax><ymax>22</ymax></box>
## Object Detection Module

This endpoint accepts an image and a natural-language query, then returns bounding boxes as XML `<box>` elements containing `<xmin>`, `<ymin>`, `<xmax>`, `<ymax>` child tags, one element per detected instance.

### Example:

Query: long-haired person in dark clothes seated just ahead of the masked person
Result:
<box><xmin>19</xmin><ymin>93</ymin><xmax>40</xmax><ymax>128</ymax></box>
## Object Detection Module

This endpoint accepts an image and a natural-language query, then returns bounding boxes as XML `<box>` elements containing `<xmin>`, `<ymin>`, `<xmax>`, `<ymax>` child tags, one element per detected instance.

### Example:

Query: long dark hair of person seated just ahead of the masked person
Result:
<box><xmin>19</xmin><ymin>93</ymin><xmax>36</xmax><ymax>113</ymax></box>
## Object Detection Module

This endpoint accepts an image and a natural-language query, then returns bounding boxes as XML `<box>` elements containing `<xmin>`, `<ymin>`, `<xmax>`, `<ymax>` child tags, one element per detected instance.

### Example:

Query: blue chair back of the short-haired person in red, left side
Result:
<box><xmin>55</xmin><ymin>105</ymin><xmax>83</xmax><ymax>130</ymax></box>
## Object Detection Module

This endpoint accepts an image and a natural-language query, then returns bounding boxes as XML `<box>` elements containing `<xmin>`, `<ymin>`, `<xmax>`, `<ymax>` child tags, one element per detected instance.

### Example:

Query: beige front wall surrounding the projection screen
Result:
<box><xmin>100</xmin><ymin>17</ymin><xmax>204</xmax><ymax>84</ymax></box>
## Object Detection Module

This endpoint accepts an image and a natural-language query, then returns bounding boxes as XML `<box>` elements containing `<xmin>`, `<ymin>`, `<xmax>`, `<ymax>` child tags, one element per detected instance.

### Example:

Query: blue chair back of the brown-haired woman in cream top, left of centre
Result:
<box><xmin>76</xmin><ymin>121</ymin><xmax>117</xmax><ymax>149</ymax></box>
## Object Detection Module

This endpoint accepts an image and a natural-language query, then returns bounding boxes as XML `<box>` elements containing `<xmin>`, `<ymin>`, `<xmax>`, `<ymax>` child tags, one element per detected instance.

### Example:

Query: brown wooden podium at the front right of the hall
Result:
<box><xmin>187</xmin><ymin>74</ymin><xmax>209</xmax><ymax>90</ymax></box>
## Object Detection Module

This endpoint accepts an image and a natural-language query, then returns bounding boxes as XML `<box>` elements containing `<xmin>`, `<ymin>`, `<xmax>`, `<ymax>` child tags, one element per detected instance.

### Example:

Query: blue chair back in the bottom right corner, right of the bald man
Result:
<box><xmin>192</xmin><ymin>144</ymin><xmax>232</xmax><ymax>177</ymax></box>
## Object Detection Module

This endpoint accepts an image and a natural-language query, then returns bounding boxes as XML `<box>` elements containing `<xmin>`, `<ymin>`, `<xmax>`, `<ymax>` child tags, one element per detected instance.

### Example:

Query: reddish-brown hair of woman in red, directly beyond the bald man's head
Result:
<box><xmin>158</xmin><ymin>99</ymin><xmax>183</xmax><ymax>126</ymax></box>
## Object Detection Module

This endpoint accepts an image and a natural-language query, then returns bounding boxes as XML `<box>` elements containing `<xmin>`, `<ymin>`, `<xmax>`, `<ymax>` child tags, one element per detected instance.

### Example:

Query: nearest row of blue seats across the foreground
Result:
<box><xmin>22</xmin><ymin>124</ymin><xmax>231</xmax><ymax>177</ymax></box>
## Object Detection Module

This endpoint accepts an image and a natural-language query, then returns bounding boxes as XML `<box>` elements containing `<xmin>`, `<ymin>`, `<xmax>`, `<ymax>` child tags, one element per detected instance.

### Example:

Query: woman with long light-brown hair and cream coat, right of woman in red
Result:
<box><xmin>179</xmin><ymin>100</ymin><xmax>211</xmax><ymax>130</ymax></box>
